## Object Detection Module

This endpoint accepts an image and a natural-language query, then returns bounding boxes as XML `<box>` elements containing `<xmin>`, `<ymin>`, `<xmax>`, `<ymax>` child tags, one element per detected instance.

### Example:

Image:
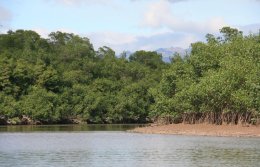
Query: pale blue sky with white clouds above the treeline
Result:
<box><xmin>0</xmin><ymin>0</ymin><xmax>260</xmax><ymax>53</ymax></box>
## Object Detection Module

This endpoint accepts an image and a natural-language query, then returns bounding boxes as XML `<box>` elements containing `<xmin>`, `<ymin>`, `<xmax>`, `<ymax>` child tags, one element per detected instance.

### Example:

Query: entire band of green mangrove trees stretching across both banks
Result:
<box><xmin>0</xmin><ymin>27</ymin><xmax>260</xmax><ymax>124</ymax></box>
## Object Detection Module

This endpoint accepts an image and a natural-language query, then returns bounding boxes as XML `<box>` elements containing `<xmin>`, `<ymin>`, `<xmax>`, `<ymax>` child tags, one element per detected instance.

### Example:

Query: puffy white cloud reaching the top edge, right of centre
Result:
<box><xmin>141</xmin><ymin>0</ymin><xmax>227</xmax><ymax>33</ymax></box>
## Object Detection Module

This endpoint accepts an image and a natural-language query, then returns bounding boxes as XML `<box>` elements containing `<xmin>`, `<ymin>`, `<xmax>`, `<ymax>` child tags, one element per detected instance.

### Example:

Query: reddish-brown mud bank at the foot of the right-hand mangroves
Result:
<box><xmin>130</xmin><ymin>124</ymin><xmax>260</xmax><ymax>137</ymax></box>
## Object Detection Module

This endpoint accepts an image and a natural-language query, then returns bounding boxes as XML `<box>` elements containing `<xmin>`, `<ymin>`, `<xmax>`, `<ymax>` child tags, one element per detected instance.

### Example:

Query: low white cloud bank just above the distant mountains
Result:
<box><xmin>86</xmin><ymin>31</ymin><xmax>200</xmax><ymax>54</ymax></box>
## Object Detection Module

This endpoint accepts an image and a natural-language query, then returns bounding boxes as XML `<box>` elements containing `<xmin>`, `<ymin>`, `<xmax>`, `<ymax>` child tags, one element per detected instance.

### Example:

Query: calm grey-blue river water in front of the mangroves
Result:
<box><xmin>0</xmin><ymin>125</ymin><xmax>260</xmax><ymax>167</ymax></box>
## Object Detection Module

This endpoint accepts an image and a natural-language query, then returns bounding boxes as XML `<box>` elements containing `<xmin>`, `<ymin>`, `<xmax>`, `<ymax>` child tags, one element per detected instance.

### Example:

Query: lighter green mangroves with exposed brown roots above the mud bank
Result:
<box><xmin>150</xmin><ymin>27</ymin><xmax>260</xmax><ymax>124</ymax></box>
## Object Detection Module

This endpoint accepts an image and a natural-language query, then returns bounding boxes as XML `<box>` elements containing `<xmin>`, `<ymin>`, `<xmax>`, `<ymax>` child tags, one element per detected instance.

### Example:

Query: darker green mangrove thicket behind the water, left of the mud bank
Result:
<box><xmin>0</xmin><ymin>30</ymin><xmax>167</xmax><ymax>123</ymax></box>
